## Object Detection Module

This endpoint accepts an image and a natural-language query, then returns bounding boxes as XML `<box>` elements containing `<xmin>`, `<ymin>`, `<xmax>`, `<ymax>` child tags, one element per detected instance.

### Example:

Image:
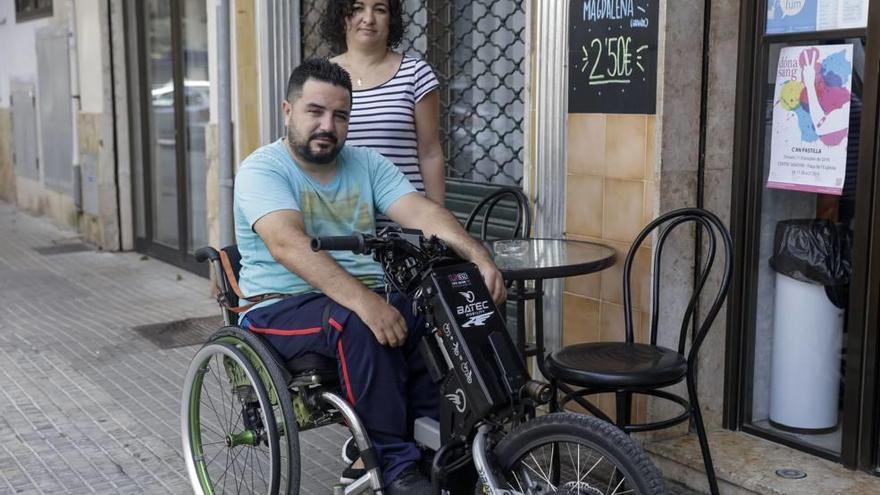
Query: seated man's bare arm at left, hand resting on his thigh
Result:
<box><xmin>254</xmin><ymin>210</ymin><xmax>407</xmax><ymax>347</ymax></box>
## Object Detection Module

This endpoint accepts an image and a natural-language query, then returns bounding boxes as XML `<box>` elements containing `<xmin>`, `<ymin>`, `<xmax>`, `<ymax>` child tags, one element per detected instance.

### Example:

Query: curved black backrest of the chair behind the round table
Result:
<box><xmin>464</xmin><ymin>186</ymin><xmax>532</xmax><ymax>241</ymax></box>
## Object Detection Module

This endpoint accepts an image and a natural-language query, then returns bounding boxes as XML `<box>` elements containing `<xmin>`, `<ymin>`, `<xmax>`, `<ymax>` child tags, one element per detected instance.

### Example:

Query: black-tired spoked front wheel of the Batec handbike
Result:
<box><xmin>494</xmin><ymin>413</ymin><xmax>667</xmax><ymax>495</ymax></box>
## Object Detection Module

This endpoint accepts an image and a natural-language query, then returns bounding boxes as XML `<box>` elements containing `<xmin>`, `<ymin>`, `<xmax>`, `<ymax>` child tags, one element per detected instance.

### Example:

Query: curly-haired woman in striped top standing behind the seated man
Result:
<box><xmin>321</xmin><ymin>0</ymin><xmax>446</xmax><ymax>212</ymax></box>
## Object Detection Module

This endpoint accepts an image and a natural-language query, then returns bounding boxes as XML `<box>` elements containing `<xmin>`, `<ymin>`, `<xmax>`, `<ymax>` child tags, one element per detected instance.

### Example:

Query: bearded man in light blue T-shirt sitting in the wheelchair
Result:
<box><xmin>234</xmin><ymin>59</ymin><xmax>506</xmax><ymax>495</ymax></box>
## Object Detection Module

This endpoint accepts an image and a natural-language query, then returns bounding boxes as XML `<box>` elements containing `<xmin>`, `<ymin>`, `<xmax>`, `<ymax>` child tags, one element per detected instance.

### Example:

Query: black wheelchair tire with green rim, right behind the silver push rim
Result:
<box><xmin>209</xmin><ymin>326</ymin><xmax>301</xmax><ymax>495</ymax></box>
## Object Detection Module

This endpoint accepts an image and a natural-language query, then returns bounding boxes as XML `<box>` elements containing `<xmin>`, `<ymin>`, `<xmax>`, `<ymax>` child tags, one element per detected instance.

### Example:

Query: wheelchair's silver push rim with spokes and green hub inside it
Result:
<box><xmin>181</xmin><ymin>342</ymin><xmax>281</xmax><ymax>494</ymax></box>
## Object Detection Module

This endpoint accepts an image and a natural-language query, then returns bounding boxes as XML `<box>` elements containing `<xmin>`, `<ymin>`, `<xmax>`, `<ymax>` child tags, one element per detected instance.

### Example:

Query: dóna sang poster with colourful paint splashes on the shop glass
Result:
<box><xmin>767</xmin><ymin>44</ymin><xmax>853</xmax><ymax>196</ymax></box>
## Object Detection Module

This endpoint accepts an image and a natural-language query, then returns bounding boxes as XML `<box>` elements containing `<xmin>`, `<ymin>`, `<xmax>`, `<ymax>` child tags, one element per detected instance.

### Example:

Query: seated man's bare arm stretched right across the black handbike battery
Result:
<box><xmin>386</xmin><ymin>193</ymin><xmax>507</xmax><ymax>304</ymax></box>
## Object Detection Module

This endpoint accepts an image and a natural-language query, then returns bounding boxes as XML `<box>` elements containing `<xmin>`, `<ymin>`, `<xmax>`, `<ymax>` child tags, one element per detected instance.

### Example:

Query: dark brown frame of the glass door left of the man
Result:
<box><xmin>123</xmin><ymin>0</ymin><xmax>208</xmax><ymax>276</ymax></box>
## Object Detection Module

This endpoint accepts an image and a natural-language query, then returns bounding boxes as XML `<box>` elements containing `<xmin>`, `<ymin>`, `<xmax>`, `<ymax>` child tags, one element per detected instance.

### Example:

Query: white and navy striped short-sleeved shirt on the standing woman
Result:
<box><xmin>346</xmin><ymin>55</ymin><xmax>440</xmax><ymax>194</ymax></box>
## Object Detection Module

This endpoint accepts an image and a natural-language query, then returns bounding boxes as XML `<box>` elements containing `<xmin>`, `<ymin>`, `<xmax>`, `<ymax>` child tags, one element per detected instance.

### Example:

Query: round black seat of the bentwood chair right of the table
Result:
<box><xmin>547</xmin><ymin>342</ymin><xmax>687</xmax><ymax>389</ymax></box>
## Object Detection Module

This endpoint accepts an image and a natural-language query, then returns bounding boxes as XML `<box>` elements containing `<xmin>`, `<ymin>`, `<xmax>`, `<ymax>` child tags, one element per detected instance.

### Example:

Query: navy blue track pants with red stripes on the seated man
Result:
<box><xmin>241</xmin><ymin>293</ymin><xmax>439</xmax><ymax>483</ymax></box>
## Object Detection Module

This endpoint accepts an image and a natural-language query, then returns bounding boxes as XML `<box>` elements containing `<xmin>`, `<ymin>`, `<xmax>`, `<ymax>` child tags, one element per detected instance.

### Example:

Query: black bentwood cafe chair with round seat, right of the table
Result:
<box><xmin>547</xmin><ymin>208</ymin><xmax>732</xmax><ymax>495</ymax></box>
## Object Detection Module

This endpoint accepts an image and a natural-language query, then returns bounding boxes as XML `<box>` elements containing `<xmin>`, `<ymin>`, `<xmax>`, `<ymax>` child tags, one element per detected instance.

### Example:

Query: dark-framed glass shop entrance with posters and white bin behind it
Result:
<box><xmin>725</xmin><ymin>0</ymin><xmax>880</xmax><ymax>470</ymax></box>
